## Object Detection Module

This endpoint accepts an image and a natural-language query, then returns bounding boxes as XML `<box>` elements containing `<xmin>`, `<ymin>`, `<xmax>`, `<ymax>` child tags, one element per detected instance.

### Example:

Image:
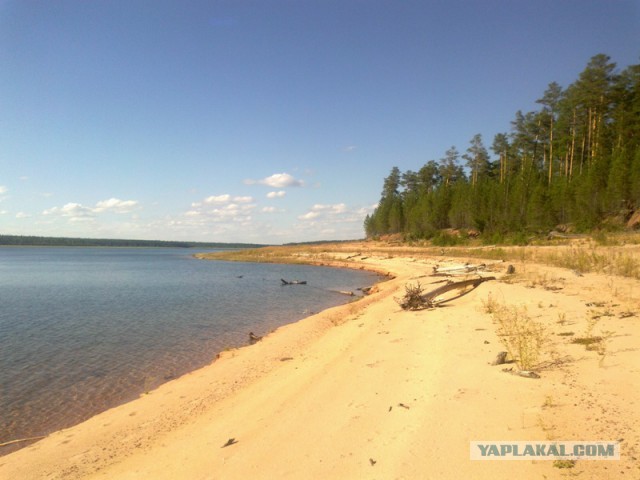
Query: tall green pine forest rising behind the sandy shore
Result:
<box><xmin>364</xmin><ymin>54</ymin><xmax>640</xmax><ymax>241</ymax></box>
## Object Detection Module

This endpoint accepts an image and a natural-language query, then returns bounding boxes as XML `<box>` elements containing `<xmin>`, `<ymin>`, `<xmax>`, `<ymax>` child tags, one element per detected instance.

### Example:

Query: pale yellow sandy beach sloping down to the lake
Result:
<box><xmin>0</xmin><ymin>245</ymin><xmax>640</xmax><ymax>480</ymax></box>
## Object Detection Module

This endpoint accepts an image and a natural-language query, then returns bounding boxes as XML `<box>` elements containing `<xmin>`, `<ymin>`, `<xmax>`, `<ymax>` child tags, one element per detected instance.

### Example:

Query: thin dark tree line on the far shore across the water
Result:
<box><xmin>0</xmin><ymin>235</ymin><xmax>265</xmax><ymax>248</ymax></box>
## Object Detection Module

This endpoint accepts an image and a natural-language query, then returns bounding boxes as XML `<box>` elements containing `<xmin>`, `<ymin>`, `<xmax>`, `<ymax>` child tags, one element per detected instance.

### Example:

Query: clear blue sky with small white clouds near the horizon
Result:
<box><xmin>0</xmin><ymin>0</ymin><xmax>640</xmax><ymax>243</ymax></box>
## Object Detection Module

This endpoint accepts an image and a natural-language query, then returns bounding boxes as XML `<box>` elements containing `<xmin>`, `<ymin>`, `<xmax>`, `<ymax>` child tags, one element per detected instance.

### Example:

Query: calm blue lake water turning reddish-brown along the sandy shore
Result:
<box><xmin>0</xmin><ymin>247</ymin><xmax>378</xmax><ymax>454</ymax></box>
